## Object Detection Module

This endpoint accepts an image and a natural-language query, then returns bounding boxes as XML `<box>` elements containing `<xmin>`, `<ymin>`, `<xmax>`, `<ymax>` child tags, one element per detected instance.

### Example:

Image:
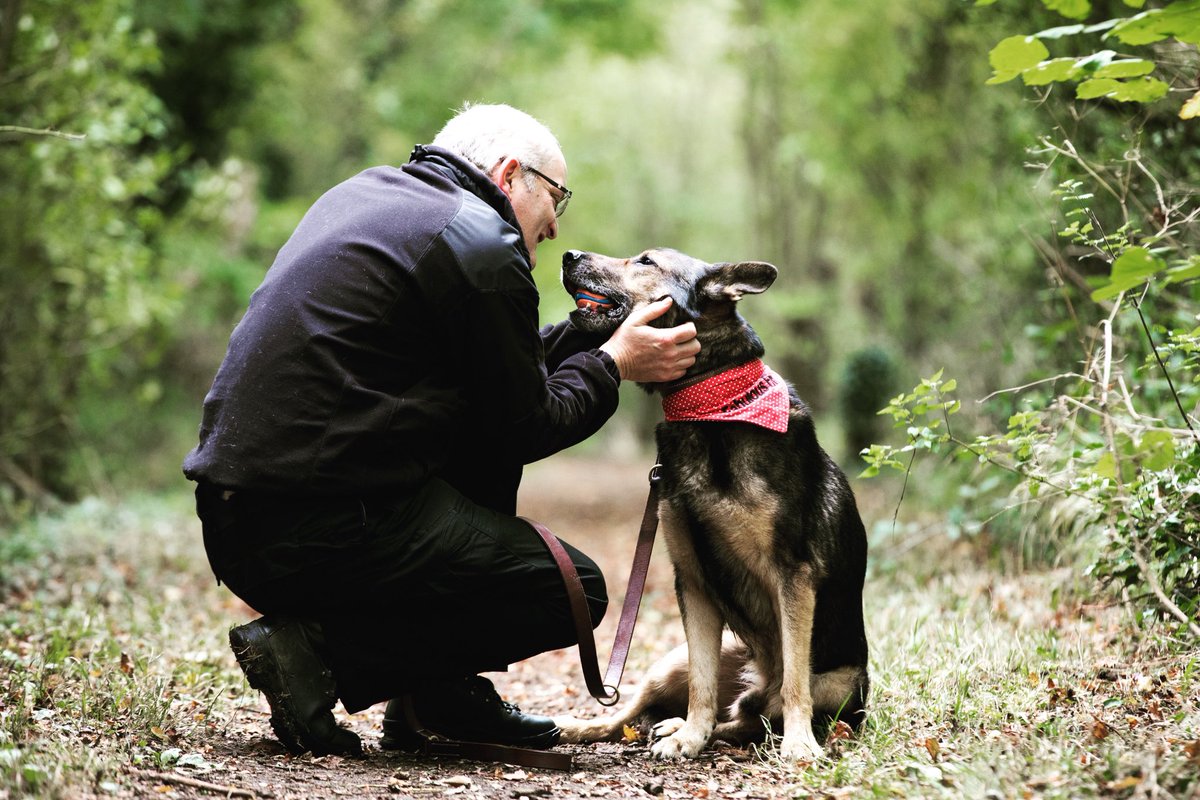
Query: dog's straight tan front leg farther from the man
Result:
<box><xmin>779</xmin><ymin>570</ymin><xmax>823</xmax><ymax>762</ymax></box>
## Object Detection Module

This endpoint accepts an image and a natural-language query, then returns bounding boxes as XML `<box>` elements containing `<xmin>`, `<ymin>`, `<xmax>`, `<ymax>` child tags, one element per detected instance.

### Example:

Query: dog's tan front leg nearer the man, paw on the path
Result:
<box><xmin>650</xmin><ymin>585</ymin><xmax>724</xmax><ymax>758</ymax></box>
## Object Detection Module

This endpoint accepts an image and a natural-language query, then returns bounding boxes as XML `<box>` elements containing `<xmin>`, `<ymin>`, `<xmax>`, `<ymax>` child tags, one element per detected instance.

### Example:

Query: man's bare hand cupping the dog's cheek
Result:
<box><xmin>600</xmin><ymin>297</ymin><xmax>700</xmax><ymax>384</ymax></box>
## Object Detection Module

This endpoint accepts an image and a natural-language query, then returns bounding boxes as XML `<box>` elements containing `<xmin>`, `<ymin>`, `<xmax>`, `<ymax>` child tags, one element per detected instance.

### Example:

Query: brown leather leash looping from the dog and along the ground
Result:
<box><xmin>403</xmin><ymin>464</ymin><xmax>662</xmax><ymax>771</ymax></box>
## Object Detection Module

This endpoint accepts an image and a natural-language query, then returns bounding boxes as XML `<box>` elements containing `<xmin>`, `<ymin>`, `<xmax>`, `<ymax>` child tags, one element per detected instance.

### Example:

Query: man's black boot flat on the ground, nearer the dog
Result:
<box><xmin>379</xmin><ymin>675</ymin><xmax>560</xmax><ymax>750</ymax></box>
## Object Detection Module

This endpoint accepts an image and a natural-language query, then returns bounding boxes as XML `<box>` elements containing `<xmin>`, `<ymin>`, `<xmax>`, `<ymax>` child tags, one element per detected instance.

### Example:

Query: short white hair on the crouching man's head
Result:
<box><xmin>432</xmin><ymin>103</ymin><xmax>563</xmax><ymax>188</ymax></box>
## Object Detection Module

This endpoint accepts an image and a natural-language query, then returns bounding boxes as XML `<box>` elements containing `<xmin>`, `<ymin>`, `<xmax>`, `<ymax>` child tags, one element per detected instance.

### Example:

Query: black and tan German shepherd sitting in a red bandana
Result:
<box><xmin>556</xmin><ymin>248</ymin><xmax>870</xmax><ymax>762</ymax></box>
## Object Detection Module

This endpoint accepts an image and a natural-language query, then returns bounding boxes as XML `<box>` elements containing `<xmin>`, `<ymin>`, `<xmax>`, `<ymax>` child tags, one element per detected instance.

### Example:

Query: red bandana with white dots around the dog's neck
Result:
<box><xmin>662</xmin><ymin>359</ymin><xmax>791</xmax><ymax>433</ymax></box>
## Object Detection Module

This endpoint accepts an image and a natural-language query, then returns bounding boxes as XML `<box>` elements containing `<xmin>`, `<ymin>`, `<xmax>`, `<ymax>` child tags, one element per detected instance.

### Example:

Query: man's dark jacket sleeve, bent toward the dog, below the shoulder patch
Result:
<box><xmin>462</xmin><ymin>290</ymin><xmax>620</xmax><ymax>464</ymax></box>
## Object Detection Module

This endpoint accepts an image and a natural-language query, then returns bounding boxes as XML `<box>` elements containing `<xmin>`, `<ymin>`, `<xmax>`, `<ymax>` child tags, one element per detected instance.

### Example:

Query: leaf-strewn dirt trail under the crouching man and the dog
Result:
<box><xmin>159</xmin><ymin>458</ymin><xmax>774</xmax><ymax>800</ymax></box>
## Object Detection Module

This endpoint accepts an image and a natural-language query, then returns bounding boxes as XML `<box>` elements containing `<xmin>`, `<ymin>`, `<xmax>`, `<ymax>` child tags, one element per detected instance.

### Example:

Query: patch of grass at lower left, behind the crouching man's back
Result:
<box><xmin>0</xmin><ymin>499</ymin><xmax>241</xmax><ymax>798</ymax></box>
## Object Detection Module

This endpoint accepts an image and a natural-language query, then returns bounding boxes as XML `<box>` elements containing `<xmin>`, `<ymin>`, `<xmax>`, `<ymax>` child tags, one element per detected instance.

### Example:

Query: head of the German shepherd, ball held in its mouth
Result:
<box><xmin>563</xmin><ymin>248</ymin><xmax>779</xmax><ymax>333</ymax></box>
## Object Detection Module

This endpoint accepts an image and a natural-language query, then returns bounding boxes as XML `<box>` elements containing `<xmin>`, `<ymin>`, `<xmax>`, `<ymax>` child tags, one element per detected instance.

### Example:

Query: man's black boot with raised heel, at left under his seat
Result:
<box><xmin>229</xmin><ymin>616</ymin><xmax>362</xmax><ymax>756</ymax></box>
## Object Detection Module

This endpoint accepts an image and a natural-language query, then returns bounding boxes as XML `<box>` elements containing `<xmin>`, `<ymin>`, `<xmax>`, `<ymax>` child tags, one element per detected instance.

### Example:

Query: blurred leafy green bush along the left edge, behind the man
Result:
<box><xmin>0</xmin><ymin>0</ymin><xmax>175</xmax><ymax>506</ymax></box>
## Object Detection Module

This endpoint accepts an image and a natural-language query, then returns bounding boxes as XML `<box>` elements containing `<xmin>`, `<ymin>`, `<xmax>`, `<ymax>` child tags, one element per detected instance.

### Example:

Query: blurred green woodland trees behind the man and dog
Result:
<box><xmin>0</xmin><ymin>0</ymin><xmax>1200</xmax><ymax>633</ymax></box>
